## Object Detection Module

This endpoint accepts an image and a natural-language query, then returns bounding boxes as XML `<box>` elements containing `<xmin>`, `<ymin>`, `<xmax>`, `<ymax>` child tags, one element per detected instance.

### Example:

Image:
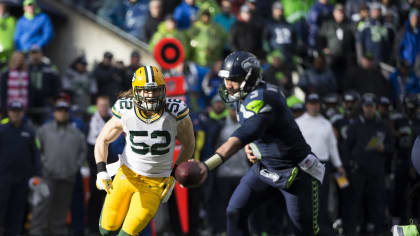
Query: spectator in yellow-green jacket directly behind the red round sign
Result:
<box><xmin>149</xmin><ymin>15</ymin><xmax>190</xmax><ymax>60</ymax></box>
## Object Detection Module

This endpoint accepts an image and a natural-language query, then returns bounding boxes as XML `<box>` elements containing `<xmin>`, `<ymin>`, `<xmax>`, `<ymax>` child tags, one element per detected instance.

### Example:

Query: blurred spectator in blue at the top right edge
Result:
<box><xmin>399</xmin><ymin>9</ymin><xmax>420</xmax><ymax>65</ymax></box>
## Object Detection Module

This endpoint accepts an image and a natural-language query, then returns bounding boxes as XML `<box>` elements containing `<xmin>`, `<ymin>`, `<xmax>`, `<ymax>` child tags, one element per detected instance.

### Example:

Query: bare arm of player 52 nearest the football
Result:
<box><xmin>175</xmin><ymin>116</ymin><xmax>195</xmax><ymax>165</ymax></box>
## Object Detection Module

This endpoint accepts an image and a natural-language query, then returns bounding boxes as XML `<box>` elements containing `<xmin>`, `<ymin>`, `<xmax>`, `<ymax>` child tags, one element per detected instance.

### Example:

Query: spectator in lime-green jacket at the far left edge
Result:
<box><xmin>0</xmin><ymin>2</ymin><xmax>16</xmax><ymax>70</ymax></box>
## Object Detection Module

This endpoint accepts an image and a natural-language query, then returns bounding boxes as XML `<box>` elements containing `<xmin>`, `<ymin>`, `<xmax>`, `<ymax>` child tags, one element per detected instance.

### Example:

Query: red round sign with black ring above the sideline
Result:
<box><xmin>153</xmin><ymin>38</ymin><xmax>184</xmax><ymax>69</ymax></box>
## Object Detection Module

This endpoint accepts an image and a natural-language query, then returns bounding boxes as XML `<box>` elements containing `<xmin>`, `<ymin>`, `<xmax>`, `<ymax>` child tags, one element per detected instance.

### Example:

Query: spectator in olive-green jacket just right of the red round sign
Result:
<box><xmin>187</xmin><ymin>10</ymin><xmax>227</xmax><ymax>67</ymax></box>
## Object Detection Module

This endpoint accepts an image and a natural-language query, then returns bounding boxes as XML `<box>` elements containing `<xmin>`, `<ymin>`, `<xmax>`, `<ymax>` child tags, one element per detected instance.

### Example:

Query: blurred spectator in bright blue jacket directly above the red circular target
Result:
<box><xmin>174</xmin><ymin>0</ymin><xmax>199</xmax><ymax>30</ymax></box>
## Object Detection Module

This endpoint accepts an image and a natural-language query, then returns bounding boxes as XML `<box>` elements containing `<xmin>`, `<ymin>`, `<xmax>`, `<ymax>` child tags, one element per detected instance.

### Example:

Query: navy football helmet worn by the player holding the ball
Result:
<box><xmin>218</xmin><ymin>51</ymin><xmax>261</xmax><ymax>103</ymax></box>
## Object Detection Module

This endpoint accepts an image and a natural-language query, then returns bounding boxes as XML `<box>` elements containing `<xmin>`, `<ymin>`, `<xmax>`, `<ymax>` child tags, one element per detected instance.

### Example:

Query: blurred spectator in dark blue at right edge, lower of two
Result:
<box><xmin>389</xmin><ymin>60</ymin><xmax>420</xmax><ymax>104</ymax></box>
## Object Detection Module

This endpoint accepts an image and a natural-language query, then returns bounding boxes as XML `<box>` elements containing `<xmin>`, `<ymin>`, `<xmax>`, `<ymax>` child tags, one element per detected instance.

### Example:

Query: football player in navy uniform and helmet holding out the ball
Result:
<box><xmin>194</xmin><ymin>51</ymin><xmax>333</xmax><ymax>236</ymax></box>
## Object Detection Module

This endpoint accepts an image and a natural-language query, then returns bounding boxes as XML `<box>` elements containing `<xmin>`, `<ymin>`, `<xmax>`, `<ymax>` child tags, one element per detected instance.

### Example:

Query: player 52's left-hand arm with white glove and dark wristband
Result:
<box><xmin>95</xmin><ymin>117</ymin><xmax>123</xmax><ymax>193</ymax></box>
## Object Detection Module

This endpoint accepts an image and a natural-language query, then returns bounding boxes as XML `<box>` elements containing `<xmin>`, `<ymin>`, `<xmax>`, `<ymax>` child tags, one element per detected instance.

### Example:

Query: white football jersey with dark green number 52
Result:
<box><xmin>112</xmin><ymin>98</ymin><xmax>189</xmax><ymax>177</ymax></box>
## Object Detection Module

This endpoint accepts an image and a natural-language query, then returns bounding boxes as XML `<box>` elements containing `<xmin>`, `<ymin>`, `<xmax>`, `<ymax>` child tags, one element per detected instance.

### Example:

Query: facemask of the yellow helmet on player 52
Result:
<box><xmin>133</xmin><ymin>83</ymin><xmax>166</xmax><ymax>112</ymax></box>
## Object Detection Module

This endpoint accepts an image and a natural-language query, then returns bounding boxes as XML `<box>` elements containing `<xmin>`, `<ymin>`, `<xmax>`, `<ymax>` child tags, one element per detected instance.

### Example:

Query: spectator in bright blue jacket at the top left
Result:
<box><xmin>14</xmin><ymin>0</ymin><xmax>53</xmax><ymax>52</ymax></box>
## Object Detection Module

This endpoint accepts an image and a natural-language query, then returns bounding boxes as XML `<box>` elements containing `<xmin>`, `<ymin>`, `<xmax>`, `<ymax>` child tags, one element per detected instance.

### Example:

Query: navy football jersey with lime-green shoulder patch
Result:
<box><xmin>232</xmin><ymin>83</ymin><xmax>311</xmax><ymax>169</ymax></box>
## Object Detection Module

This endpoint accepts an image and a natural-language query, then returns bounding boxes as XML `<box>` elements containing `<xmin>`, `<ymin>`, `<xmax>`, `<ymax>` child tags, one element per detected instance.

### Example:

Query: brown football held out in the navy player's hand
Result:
<box><xmin>175</xmin><ymin>161</ymin><xmax>201</xmax><ymax>188</ymax></box>
